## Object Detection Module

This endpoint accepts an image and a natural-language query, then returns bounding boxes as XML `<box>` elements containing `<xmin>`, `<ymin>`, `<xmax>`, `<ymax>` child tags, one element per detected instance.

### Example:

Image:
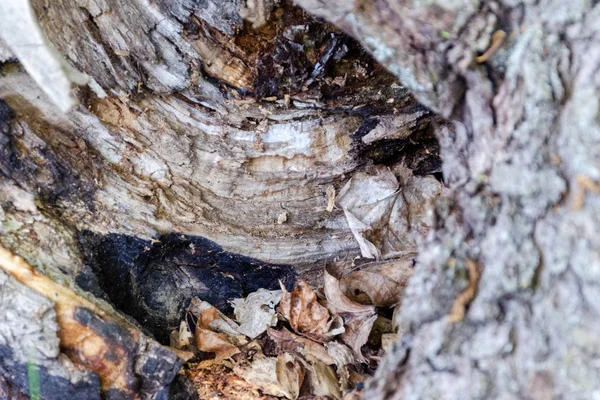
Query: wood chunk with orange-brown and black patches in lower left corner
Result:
<box><xmin>0</xmin><ymin>248</ymin><xmax>181</xmax><ymax>399</ymax></box>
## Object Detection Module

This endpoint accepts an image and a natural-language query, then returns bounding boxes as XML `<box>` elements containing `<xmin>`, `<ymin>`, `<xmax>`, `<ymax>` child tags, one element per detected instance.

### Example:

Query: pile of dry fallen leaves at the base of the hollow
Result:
<box><xmin>177</xmin><ymin>254</ymin><xmax>414</xmax><ymax>400</ymax></box>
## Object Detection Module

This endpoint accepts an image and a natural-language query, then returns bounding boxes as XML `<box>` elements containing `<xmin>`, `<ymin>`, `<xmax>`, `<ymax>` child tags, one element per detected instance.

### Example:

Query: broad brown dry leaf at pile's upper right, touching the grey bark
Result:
<box><xmin>340</xmin><ymin>254</ymin><xmax>415</xmax><ymax>307</ymax></box>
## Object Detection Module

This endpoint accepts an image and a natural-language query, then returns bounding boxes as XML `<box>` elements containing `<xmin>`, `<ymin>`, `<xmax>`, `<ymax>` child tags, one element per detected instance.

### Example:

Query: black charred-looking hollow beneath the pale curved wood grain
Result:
<box><xmin>76</xmin><ymin>231</ymin><xmax>295</xmax><ymax>344</ymax></box>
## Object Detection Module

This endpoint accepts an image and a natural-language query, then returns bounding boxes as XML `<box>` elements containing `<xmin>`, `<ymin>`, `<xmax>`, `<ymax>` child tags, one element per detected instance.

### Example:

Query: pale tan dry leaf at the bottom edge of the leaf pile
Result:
<box><xmin>233</xmin><ymin>354</ymin><xmax>287</xmax><ymax>397</ymax></box>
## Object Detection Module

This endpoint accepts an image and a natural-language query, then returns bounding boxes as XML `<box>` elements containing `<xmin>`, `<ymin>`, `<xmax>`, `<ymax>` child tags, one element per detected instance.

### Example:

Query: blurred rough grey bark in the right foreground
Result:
<box><xmin>298</xmin><ymin>0</ymin><xmax>600</xmax><ymax>399</ymax></box>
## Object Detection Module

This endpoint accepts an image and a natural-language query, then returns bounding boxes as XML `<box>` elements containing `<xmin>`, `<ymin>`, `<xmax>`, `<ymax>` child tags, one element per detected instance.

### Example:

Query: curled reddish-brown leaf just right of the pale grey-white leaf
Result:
<box><xmin>278</xmin><ymin>280</ymin><xmax>330</xmax><ymax>340</ymax></box>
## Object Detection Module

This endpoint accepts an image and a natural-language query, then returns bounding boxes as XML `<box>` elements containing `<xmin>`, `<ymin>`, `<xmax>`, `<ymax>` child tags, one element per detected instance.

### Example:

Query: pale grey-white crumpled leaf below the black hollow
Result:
<box><xmin>231</xmin><ymin>289</ymin><xmax>282</xmax><ymax>339</ymax></box>
